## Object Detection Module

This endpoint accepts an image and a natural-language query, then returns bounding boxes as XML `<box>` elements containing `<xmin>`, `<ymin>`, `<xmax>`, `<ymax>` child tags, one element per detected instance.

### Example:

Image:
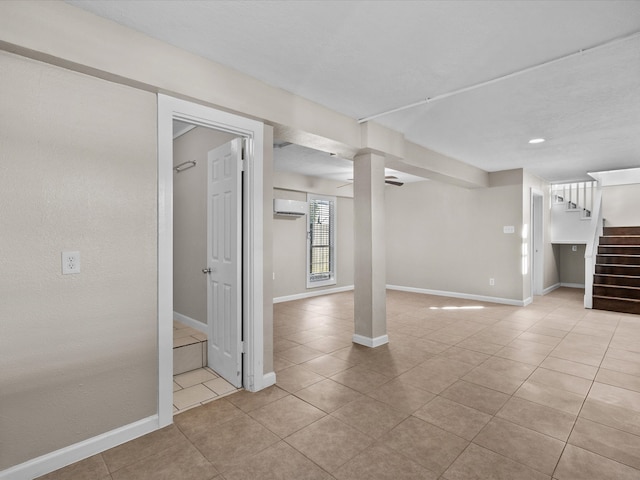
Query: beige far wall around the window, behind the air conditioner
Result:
<box><xmin>271</xmin><ymin>189</ymin><xmax>353</xmax><ymax>298</ymax></box>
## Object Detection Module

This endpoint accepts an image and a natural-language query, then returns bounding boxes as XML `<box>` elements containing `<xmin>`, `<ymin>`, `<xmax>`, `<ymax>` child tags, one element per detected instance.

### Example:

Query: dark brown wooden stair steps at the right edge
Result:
<box><xmin>593</xmin><ymin>227</ymin><xmax>640</xmax><ymax>315</ymax></box>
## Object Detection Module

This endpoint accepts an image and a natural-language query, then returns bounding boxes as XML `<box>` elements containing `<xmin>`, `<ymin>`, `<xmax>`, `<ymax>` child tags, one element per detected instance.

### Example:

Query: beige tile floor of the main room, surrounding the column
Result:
<box><xmin>44</xmin><ymin>289</ymin><xmax>640</xmax><ymax>480</ymax></box>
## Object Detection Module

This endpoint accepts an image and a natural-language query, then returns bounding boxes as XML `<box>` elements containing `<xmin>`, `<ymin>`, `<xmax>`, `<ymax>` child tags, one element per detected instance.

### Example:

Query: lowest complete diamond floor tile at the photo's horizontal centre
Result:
<box><xmin>286</xmin><ymin>416</ymin><xmax>373</xmax><ymax>473</ymax></box>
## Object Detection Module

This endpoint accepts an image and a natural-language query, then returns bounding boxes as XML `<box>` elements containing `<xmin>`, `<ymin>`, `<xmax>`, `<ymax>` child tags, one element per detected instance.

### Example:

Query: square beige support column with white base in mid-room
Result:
<box><xmin>353</xmin><ymin>153</ymin><xmax>389</xmax><ymax>347</ymax></box>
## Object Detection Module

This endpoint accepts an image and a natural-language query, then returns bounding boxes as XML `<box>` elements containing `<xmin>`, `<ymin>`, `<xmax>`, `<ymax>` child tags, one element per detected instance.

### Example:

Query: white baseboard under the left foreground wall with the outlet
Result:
<box><xmin>0</xmin><ymin>415</ymin><xmax>159</xmax><ymax>480</ymax></box>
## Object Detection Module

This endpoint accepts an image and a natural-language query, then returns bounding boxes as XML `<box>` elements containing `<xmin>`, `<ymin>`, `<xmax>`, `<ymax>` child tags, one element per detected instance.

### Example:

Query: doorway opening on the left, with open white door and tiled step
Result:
<box><xmin>173</xmin><ymin>125</ymin><xmax>243</xmax><ymax>413</ymax></box>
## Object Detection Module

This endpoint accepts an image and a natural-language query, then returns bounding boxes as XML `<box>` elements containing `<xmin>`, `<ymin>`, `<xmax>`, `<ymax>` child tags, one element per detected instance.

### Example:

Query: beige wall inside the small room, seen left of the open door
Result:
<box><xmin>173</xmin><ymin>127</ymin><xmax>234</xmax><ymax>323</ymax></box>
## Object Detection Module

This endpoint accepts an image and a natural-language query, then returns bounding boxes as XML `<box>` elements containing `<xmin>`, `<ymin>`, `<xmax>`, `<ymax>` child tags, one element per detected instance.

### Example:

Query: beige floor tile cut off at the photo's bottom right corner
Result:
<box><xmin>554</xmin><ymin>445</ymin><xmax>640</xmax><ymax>480</ymax></box>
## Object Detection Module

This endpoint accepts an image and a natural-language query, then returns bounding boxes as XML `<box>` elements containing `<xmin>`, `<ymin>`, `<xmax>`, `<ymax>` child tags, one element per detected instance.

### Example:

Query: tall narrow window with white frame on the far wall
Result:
<box><xmin>307</xmin><ymin>194</ymin><xmax>336</xmax><ymax>288</ymax></box>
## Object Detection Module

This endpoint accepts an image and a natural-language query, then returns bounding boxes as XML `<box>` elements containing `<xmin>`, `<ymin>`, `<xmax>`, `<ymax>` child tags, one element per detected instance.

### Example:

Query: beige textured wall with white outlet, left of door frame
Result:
<box><xmin>0</xmin><ymin>52</ymin><xmax>158</xmax><ymax>470</ymax></box>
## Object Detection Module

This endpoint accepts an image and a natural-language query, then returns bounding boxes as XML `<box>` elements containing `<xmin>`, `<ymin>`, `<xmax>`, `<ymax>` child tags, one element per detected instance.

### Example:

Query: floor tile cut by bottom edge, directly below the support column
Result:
<box><xmin>335</xmin><ymin>445</ymin><xmax>438</xmax><ymax>480</ymax></box>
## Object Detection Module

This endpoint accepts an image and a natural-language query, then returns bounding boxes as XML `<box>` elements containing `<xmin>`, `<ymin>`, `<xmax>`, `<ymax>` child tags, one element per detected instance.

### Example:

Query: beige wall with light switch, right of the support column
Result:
<box><xmin>386</xmin><ymin>174</ymin><xmax>523</xmax><ymax>301</ymax></box>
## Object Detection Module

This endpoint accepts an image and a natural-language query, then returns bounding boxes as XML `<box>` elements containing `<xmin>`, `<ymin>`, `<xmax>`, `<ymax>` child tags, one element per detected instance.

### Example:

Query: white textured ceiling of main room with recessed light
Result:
<box><xmin>69</xmin><ymin>0</ymin><xmax>640</xmax><ymax>181</ymax></box>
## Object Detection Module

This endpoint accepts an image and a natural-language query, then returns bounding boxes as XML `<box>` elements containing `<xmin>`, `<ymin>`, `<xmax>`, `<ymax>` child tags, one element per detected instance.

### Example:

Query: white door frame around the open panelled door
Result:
<box><xmin>158</xmin><ymin>94</ymin><xmax>266</xmax><ymax>427</ymax></box>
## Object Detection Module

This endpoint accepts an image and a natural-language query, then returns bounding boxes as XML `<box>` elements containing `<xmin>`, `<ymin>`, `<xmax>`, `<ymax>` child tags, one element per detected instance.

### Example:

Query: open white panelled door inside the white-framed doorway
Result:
<box><xmin>204</xmin><ymin>138</ymin><xmax>242</xmax><ymax>387</ymax></box>
